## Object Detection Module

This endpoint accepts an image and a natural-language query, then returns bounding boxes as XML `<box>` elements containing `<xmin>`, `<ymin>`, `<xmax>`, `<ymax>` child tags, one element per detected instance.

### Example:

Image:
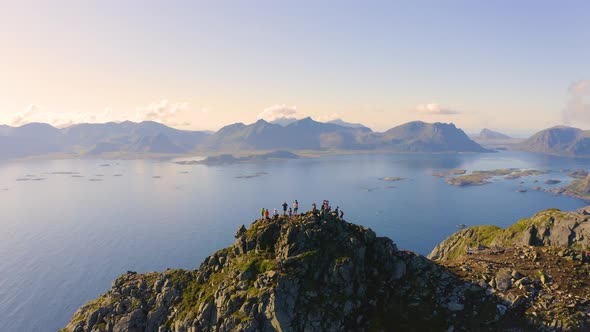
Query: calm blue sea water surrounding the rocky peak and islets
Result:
<box><xmin>0</xmin><ymin>151</ymin><xmax>588</xmax><ymax>331</ymax></box>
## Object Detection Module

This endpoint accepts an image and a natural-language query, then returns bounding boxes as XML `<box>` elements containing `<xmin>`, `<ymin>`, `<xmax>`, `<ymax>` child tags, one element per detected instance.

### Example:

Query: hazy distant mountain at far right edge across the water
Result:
<box><xmin>518</xmin><ymin>126</ymin><xmax>590</xmax><ymax>157</ymax></box>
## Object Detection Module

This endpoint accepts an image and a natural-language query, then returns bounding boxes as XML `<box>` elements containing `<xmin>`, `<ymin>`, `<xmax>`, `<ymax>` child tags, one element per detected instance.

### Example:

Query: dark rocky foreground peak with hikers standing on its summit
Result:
<box><xmin>62</xmin><ymin>212</ymin><xmax>523</xmax><ymax>332</ymax></box>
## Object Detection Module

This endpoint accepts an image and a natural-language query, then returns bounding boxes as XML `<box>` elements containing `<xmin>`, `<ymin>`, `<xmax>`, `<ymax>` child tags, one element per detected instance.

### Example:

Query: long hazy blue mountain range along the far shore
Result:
<box><xmin>0</xmin><ymin>117</ymin><xmax>487</xmax><ymax>159</ymax></box>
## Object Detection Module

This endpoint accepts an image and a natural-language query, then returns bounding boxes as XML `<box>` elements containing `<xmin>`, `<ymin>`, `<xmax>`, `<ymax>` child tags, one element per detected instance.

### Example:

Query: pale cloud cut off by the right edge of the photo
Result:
<box><xmin>563</xmin><ymin>80</ymin><xmax>590</xmax><ymax>126</ymax></box>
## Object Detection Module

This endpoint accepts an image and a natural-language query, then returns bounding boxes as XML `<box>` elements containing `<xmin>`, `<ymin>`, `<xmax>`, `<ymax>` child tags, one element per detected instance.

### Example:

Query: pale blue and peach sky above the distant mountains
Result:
<box><xmin>0</xmin><ymin>0</ymin><xmax>590</xmax><ymax>134</ymax></box>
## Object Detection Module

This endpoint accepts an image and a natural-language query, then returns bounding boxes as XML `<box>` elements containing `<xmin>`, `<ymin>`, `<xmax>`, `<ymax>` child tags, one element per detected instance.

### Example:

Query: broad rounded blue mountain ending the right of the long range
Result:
<box><xmin>373</xmin><ymin>121</ymin><xmax>488</xmax><ymax>152</ymax></box>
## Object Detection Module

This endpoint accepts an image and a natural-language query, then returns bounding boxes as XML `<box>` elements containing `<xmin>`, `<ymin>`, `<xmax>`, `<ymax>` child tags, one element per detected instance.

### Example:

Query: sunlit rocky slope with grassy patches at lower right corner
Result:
<box><xmin>428</xmin><ymin>208</ymin><xmax>590</xmax><ymax>331</ymax></box>
